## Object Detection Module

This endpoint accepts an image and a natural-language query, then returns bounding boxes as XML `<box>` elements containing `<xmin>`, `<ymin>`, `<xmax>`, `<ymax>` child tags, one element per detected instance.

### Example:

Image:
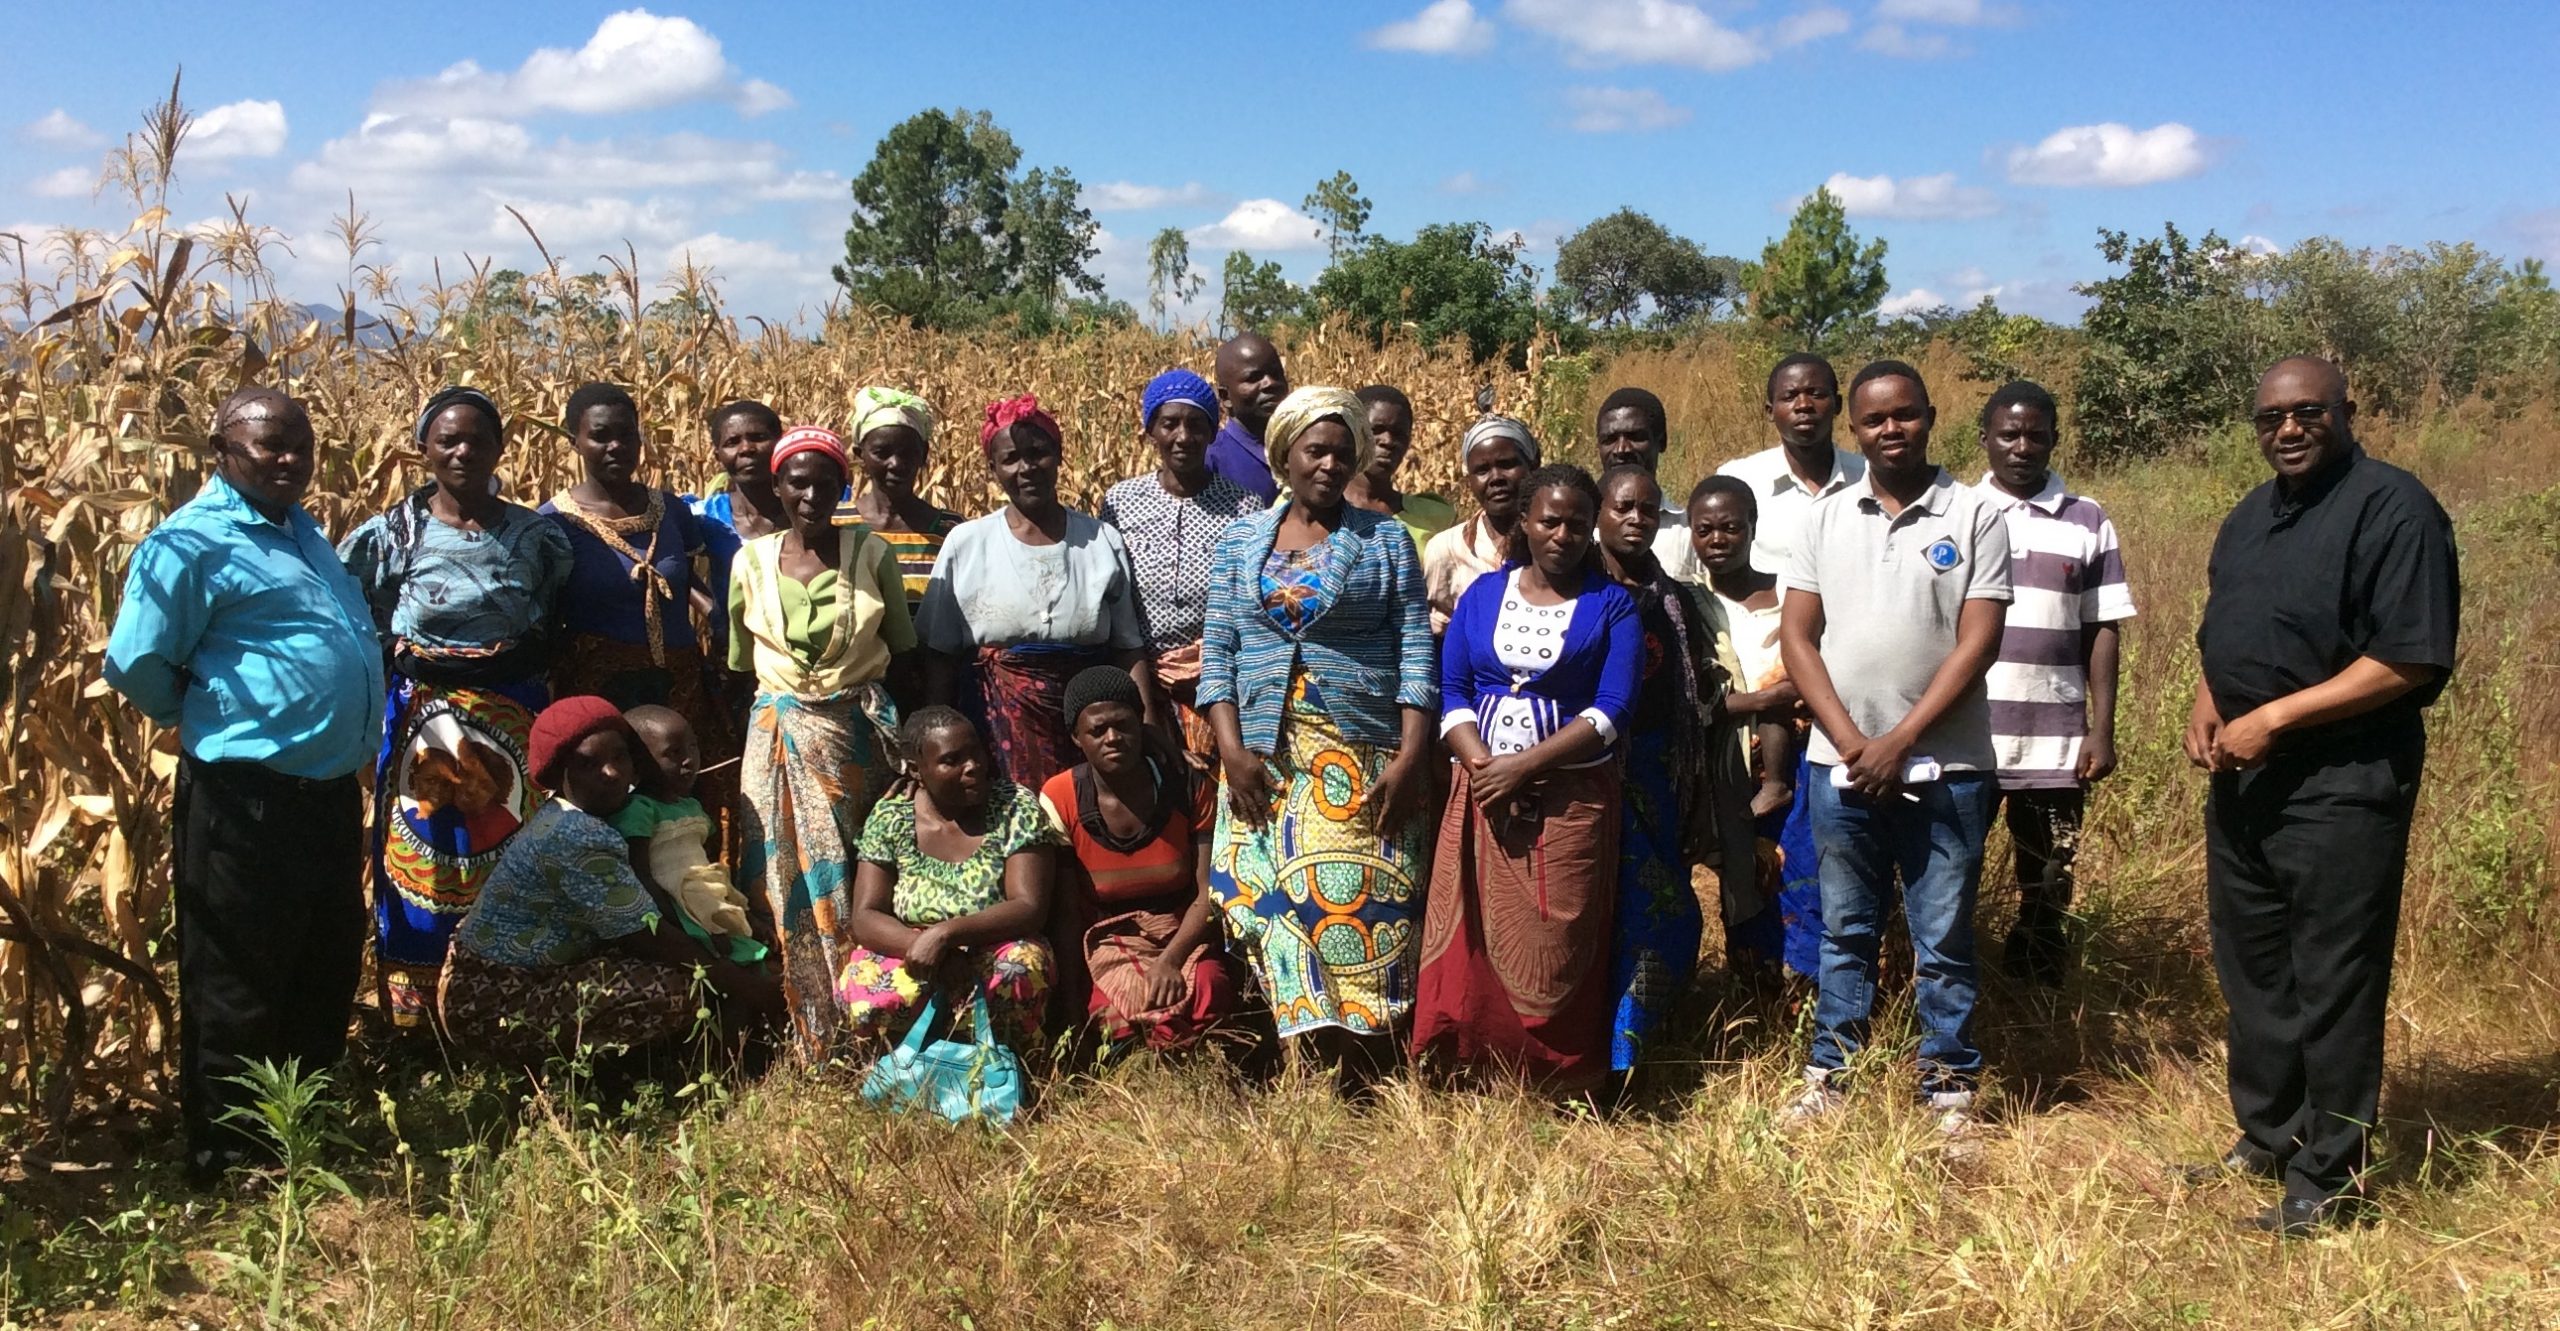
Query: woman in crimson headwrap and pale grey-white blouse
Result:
<box><xmin>916</xmin><ymin>394</ymin><xmax>1170</xmax><ymax>791</ymax></box>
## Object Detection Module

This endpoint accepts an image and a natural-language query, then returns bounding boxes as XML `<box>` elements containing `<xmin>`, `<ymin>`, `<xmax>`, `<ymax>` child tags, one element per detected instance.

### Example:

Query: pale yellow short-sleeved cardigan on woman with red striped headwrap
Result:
<box><xmin>730</xmin><ymin>525</ymin><xmax>916</xmax><ymax>699</ymax></box>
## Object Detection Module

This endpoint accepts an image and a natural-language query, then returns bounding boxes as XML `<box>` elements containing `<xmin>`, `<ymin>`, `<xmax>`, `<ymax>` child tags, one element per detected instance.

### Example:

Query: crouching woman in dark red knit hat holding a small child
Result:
<box><xmin>438</xmin><ymin>696</ymin><xmax>783</xmax><ymax>1062</ymax></box>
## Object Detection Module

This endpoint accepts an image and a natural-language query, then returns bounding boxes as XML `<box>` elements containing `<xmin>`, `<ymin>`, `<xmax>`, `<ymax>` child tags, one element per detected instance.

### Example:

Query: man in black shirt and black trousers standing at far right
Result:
<box><xmin>2186</xmin><ymin>356</ymin><xmax>2460</xmax><ymax>1236</ymax></box>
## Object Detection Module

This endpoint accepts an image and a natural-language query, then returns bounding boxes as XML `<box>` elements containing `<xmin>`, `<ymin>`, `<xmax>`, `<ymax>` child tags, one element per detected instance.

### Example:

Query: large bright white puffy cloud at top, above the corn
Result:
<box><xmin>374</xmin><ymin>10</ymin><xmax>791</xmax><ymax>118</ymax></box>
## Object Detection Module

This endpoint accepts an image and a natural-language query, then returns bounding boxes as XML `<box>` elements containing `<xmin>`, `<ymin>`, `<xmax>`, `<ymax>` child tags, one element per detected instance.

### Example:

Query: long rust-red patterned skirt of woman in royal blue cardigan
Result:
<box><xmin>1413</xmin><ymin>763</ymin><xmax>1620</xmax><ymax>1093</ymax></box>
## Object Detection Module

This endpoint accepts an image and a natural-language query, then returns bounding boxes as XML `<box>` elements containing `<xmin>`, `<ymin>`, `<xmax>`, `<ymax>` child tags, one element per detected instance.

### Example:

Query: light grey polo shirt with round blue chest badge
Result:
<box><xmin>1784</xmin><ymin>468</ymin><xmax>2010</xmax><ymax>770</ymax></box>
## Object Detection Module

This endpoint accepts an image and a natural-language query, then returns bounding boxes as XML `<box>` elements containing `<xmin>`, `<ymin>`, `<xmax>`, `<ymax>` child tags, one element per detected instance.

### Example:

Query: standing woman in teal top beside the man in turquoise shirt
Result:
<box><xmin>338</xmin><ymin>387</ymin><xmax>571</xmax><ymax>1026</ymax></box>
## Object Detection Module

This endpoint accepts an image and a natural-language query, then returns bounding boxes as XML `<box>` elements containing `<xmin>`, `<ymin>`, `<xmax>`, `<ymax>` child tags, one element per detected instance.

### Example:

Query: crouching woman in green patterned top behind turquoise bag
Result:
<box><xmin>835</xmin><ymin>706</ymin><xmax>1057</xmax><ymax>1055</ymax></box>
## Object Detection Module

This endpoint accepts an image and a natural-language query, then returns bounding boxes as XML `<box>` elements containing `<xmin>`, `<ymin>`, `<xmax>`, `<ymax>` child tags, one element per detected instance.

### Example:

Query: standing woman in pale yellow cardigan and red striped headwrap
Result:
<box><xmin>730</xmin><ymin>425</ymin><xmax>916</xmax><ymax>1057</ymax></box>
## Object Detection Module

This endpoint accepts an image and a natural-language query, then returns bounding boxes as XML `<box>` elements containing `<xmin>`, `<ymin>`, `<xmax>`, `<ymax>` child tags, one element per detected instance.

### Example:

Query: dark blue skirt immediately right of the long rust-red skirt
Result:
<box><xmin>1608</xmin><ymin>729</ymin><xmax>1708</xmax><ymax>1072</ymax></box>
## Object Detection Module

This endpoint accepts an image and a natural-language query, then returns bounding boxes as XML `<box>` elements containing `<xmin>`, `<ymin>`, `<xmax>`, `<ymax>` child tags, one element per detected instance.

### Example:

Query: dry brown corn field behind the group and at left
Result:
<box><xmin>0</xmin><ymin>122</ymin><xmax>1617</xmax><ymax>1131</ymax></box>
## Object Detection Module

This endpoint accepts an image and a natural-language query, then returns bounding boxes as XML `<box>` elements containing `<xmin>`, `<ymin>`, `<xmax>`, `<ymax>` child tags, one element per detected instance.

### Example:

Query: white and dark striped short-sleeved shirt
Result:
<box><xmin>1979</xmin><ymin>471</ymin><xmax>2132</xmax><ymax>791</ymax></box>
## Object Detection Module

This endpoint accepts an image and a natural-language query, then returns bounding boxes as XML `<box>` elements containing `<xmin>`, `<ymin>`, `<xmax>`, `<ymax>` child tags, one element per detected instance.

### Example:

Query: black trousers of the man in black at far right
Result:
<box><xmin>2204</xmin><ymin>737</ymin><xmax>2424</xmax><ymax>1200</ymax></box>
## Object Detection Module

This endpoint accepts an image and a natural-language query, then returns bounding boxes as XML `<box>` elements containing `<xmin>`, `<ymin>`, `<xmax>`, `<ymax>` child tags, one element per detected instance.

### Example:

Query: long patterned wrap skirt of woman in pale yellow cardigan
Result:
<box><xmin>737</xmin><ymin>683</ymin><xmax>899</xmax><ymax>1057</ymax></box>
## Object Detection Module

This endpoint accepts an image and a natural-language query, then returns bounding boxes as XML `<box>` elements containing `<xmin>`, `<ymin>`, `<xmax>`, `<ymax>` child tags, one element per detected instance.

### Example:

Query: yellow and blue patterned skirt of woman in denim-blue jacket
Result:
<box><xmin>1208</xmin><ymin>673</ymin><xmax>1423</xmax><ymax>1034</ymax></box>
